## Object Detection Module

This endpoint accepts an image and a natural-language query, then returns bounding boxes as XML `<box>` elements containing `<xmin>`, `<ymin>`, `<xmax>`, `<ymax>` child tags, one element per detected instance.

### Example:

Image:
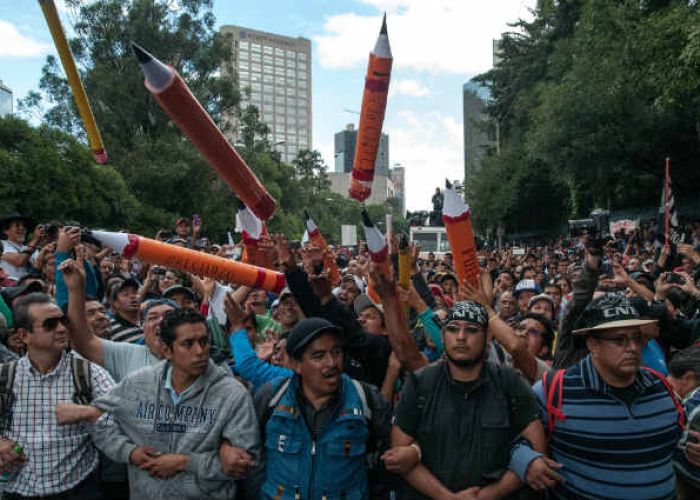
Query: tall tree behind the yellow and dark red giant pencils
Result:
<box><xmin>23</xmin><ymin>0</ymin><xmax>239</xmax><ymax>235</ymax></box>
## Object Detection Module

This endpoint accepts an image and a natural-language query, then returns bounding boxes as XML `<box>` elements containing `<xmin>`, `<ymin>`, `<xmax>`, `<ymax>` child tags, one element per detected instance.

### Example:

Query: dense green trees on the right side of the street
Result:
<box><xmin>468</xmin><ymin>0</ymin><xmax>700</xmax><ymax>234</ymax></box>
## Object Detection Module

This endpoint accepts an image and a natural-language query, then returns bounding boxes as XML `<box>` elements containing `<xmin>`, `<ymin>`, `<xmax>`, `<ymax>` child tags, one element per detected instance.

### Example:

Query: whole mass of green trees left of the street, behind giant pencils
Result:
<box><xmin>6</xmin><ymin>0</ymin><xmax>405</xmax><ymax>246</ymax></box>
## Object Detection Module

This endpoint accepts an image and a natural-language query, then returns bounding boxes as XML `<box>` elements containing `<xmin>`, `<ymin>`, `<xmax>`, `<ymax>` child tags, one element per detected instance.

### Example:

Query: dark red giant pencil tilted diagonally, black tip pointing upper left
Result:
<box><xmin>132</xmin><ymin>44</ymin><xmax>275</xmax><ymax>220</ymax></box>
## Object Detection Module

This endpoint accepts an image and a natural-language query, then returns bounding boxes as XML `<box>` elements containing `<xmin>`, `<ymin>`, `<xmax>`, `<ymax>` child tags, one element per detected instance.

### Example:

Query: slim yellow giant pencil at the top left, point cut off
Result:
<box><xmin>39</xmin><ymin>0</ymin><xmax>107</xmax><ymax>164</ymax></box>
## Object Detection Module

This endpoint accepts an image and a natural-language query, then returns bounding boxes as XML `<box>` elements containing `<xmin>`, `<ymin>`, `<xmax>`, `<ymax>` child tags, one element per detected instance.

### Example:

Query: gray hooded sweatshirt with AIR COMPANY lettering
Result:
<box><xmin>91</xmin><ymin>360</ymin><xmax>260</xmax><ymax>500</ymax></box>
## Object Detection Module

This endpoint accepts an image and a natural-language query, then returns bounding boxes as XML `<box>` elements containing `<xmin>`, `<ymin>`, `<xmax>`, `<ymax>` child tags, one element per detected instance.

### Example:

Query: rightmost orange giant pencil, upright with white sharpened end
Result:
<box><xmin>442</xmin><ymin>182</ymin><xmax>479</xmax><ymax>287</ymax></box>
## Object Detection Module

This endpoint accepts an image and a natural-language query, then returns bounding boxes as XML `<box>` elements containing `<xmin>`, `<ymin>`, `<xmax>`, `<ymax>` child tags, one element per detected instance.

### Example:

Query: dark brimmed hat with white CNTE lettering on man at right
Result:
<box><xmin>572</xmin><ymin>293</ymin><xmax>657</xmax><ymax>335</ymax></box>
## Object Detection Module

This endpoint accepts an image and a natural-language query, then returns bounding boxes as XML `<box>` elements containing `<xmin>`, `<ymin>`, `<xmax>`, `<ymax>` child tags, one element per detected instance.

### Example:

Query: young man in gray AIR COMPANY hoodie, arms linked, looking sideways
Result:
<box><xmin>57</xmin><ymin>309</ymin><xmax>260</xmax><ymax>500</ymax></box>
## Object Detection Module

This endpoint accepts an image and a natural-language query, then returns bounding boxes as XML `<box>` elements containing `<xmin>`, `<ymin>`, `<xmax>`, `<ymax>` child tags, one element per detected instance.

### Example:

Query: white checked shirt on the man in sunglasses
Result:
<box><xmin>3</xmin><ymin>352</ymin><xmax>114</xmax><ymax>496</ymax></box>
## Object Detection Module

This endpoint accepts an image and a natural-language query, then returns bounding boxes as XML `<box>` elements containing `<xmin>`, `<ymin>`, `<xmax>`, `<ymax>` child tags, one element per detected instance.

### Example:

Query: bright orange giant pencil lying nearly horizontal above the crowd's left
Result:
<box><xmin>92</xmin><ymin>231</ymin><xmax>285</xmax><ymax>293</ymax></box>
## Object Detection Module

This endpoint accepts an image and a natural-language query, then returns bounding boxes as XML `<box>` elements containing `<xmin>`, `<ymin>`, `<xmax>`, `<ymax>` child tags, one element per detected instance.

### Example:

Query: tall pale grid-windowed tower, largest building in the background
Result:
<box><xmin>221</xmin><ymin>25</ymin><xmax>313</xmax><ymax>162</ymax></box>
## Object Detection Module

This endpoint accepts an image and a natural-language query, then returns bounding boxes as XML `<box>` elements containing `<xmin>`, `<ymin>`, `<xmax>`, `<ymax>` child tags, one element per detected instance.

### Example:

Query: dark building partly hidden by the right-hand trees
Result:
<box><xmin>462</xmin><ymin>80</ymin><xmax>493</xmax><ymax>181</ymax></box>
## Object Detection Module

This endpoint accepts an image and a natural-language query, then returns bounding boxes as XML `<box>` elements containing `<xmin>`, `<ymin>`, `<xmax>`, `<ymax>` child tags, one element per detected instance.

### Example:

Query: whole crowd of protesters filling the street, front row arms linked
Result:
<box><xmin>0</xmin><ymin>209</ymin><xmax>700</xmax><ymax>500</ymax></box>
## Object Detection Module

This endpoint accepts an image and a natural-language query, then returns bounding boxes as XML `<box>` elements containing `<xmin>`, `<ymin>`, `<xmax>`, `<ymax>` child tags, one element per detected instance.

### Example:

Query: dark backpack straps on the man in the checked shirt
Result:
<box><xmin>0</xmin><ymin>356</ymin><xmax>92</xmax><ymax>431</ymax></box>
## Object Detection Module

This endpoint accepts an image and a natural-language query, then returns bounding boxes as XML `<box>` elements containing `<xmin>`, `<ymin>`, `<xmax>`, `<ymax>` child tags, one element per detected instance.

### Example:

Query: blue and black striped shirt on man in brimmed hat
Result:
<box><xmin>534</xmin><ymin>355</ymin><xmax>681</xmax><ymax>500</ymax></box>
